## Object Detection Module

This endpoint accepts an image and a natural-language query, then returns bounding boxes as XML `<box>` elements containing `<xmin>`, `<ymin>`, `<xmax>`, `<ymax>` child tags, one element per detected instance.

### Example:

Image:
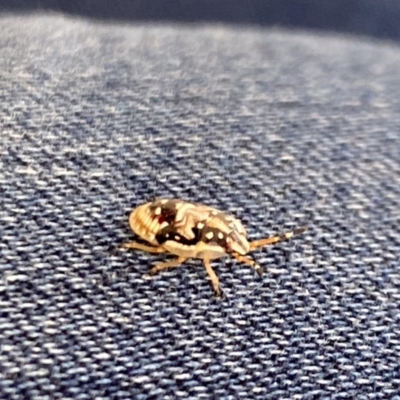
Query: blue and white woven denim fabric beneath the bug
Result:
<box><xmin>0</xmin><ymin>15</ymin><xmax>400</xmax><ymax>400</ymax></box>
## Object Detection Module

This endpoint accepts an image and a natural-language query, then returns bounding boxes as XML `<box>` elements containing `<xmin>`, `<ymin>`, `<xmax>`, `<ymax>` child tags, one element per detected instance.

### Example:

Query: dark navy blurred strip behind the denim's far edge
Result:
<box><xmin>0</xmin><ymin>0</ymin><xmax>400</xmax><ymax>39</ymax></box>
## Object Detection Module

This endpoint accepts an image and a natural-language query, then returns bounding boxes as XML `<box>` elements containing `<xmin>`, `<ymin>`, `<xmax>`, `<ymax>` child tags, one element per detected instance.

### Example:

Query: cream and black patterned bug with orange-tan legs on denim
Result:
<box><xmin>120</xmin><ymin>199</ymin><xmax>306</xmax><ymax>296</ymax></box>
